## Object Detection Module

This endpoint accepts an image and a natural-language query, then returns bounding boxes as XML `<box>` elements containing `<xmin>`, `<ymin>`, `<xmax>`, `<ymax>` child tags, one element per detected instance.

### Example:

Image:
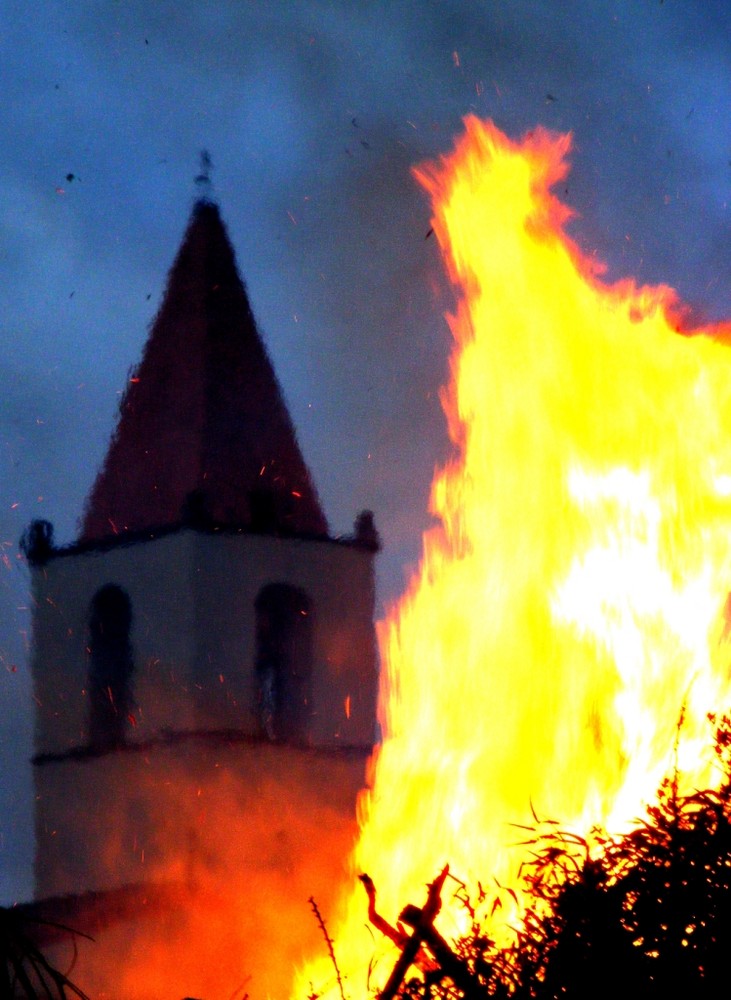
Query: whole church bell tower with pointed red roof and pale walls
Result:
<box><xmin>24</xmin><ymin>189</ymin><xmax>378</xmax><ymax>989</ymax></box>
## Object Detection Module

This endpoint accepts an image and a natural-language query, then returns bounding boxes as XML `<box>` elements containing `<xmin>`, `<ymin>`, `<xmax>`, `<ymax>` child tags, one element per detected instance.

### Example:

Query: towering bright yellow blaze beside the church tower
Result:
<box><xmin>303</xmin><ymin>118</ymin><xmax>731</xmax><ymax>989</ymax></box>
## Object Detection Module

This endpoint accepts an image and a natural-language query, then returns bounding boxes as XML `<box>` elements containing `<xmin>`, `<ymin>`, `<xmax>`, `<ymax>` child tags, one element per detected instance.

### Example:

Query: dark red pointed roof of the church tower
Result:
<box><xmin>81</xmin><ymin>199</ymin><xmax>327</xmax><ymax>542</ymax></box>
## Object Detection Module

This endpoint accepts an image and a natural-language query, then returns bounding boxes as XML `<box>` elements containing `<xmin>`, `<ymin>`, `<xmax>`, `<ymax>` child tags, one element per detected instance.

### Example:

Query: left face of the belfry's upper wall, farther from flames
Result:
<box><xmin>32</xmin><ymin>532</ymin><xmax>196</xmax><ymax>754</ymax></box>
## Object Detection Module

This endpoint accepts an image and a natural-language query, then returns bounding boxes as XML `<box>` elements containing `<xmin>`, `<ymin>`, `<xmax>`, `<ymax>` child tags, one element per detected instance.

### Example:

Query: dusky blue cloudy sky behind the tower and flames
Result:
<box><xmin>0</xmin><ymin>0</ymin><xmax>731</xmax><ymax>901</ymax></box>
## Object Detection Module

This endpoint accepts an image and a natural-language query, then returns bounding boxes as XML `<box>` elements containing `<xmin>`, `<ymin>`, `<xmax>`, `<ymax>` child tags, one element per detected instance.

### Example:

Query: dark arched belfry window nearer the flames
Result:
<box><xmin>255</xmin><ymin>583</ymin><xmax>312</xmax><ymax>743</ymax></box>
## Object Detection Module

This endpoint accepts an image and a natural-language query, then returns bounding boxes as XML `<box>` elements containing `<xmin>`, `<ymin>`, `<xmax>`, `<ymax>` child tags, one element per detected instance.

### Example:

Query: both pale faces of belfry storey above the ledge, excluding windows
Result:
<box><xmin>33</xmin><ymin>530</ymin><xmax>376</xmax><ymax>755</ymax></box>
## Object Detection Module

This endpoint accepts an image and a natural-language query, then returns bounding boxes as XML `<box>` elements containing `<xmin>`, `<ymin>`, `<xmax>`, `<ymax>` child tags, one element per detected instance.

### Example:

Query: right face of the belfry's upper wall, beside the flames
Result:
<box><xmin>191</xmin><ymin>534</ymin><xmax>376</xmax><ymax>747</ymax></box>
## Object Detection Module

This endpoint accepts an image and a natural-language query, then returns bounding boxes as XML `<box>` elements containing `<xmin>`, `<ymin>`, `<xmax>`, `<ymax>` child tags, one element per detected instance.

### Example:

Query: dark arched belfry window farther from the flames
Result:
<box><xmin>89</xmin><ymin>583</ymin><xmax>134</xmax><ymax>749</ymax></box>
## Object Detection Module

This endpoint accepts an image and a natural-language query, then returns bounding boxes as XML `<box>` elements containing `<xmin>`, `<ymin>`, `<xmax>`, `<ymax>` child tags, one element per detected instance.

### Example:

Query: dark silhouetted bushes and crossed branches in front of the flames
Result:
<box><xmin>298</xmin><ymin>717</ymin><xmax>731</xmax><ymax>1000</ymax></box>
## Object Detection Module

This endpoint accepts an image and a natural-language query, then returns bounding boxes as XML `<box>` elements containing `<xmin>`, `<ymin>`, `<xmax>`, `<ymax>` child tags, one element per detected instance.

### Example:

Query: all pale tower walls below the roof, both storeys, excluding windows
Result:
<box><xmin>33</xmin><ymin>529</ymin><xmax>376</xmax><ymax>897</ymax></box>
